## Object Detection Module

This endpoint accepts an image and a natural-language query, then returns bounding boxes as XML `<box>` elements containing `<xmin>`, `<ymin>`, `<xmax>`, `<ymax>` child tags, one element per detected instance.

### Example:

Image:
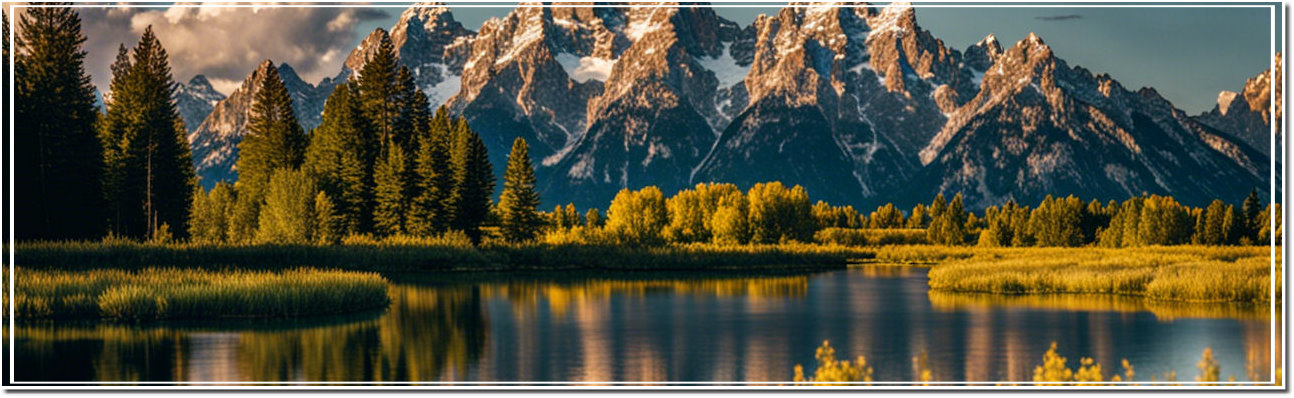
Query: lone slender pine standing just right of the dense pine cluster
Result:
<box><xmin>498</xmin><ymin>137</ymin><xmax>538</xmax><ymax>242</ymax></box>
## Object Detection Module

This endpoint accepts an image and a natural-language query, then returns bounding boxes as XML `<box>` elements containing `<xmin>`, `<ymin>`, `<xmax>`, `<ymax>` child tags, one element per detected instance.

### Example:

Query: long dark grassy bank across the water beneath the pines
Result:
<box><xmin>16</xmin><ymin>238</ymin><xmax>875</xmax><ymax>271</ymax></box>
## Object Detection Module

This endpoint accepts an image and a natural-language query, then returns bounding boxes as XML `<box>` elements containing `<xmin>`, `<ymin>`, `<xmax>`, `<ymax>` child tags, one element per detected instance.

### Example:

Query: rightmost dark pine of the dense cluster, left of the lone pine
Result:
<box><xmin>450</xmin><ymin>119</ymin><xmax>494</xmax><ymax>243</ymax></box>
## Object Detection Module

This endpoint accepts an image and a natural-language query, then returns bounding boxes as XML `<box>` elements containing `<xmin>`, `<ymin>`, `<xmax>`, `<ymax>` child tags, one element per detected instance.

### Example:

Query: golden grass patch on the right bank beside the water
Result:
<box><xmin>926</xmin><ymin>246</ymin><xmax>1281</xmax><ymax>302</ymax></box>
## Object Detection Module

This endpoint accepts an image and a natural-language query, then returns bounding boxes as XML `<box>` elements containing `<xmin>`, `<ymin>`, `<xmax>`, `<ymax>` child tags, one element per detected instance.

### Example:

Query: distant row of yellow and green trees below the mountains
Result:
<box><xmin>545</xmin><ymin>182</ymin><xmax>1281</xmax><ymax>247</ymax></box>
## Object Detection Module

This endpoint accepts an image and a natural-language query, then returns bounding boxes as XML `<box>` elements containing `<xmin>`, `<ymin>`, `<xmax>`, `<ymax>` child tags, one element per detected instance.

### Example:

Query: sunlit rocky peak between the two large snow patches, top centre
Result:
<box><xmin>545</xmin><ymin>6</ymin><xmax>741</xmax><ymax>205</ymax></box>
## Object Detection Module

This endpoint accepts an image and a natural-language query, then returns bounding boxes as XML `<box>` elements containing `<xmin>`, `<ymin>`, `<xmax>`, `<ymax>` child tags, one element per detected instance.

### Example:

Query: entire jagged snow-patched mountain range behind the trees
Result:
<box><xmin>181</xmin><ymin>3</ymin><xmax>1280</xmax><ymax>208</ymax></box>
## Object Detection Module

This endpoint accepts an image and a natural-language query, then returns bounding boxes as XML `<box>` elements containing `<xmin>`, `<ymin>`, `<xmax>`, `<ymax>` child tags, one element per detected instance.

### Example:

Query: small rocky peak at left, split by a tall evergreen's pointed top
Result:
<box><xmin>186</xmin><ymin>59</ymin><xmax>345</xmax><ymax>189</ymax></box>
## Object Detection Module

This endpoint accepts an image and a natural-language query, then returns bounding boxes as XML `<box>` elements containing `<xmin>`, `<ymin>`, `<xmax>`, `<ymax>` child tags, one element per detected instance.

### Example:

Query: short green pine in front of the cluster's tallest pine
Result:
<box><xmin>373</xmin><ymin>146</ymin><xmax>409</xmax><ymax>235</ymax></box>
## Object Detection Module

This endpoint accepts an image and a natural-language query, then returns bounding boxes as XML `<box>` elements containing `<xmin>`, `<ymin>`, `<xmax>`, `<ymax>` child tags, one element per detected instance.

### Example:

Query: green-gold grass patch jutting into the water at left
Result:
<box><xmin>14</xmin><ymin>269</ymin><xmax>388</xmax><ymax>320</ymax></box>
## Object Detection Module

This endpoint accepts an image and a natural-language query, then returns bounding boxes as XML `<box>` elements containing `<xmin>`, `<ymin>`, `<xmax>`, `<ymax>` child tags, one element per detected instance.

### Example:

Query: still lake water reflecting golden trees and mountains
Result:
<box><xmin>14</xmin><ymin>266</ymin><xmax>1280</xmax><ymax>382</ymax></box>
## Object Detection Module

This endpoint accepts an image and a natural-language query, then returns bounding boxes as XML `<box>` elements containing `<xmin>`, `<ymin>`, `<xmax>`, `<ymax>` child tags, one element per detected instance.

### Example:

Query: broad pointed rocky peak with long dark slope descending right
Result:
<box><xmin>910</xmin><ymin>34</ymin><xmax>1266</xmax><ymax>208</ymax></box>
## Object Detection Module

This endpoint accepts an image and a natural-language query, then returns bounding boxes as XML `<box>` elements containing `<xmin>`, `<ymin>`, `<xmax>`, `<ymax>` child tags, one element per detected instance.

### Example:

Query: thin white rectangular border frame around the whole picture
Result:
<box><xmin>0</xmin><ymin>0</ymin><xmax>1290</xmax><ymax>392</ymax></box>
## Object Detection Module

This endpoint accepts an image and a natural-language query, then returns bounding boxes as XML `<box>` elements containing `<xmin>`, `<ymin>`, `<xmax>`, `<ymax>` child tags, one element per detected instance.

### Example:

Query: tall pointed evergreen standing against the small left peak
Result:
<box><xmin>232</xmin><ymin>61</ymin><xmax>305</xmax><ymax>240</ymax></box>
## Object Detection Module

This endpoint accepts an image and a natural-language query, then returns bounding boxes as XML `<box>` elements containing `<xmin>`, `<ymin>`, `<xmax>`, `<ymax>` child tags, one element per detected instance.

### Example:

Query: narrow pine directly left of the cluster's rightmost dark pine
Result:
<box><xmin>409</xmin><ymin>107</ymin><xmax>454</xmax><ymax>236</ymax></box>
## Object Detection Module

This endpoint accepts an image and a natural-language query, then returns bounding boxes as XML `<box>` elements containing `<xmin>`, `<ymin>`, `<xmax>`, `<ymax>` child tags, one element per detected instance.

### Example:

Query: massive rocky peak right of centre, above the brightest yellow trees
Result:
<box><xmin>692</xmin><ymin>4</ymin><xmax>974</xmax><ymax>204</ymax></box>
